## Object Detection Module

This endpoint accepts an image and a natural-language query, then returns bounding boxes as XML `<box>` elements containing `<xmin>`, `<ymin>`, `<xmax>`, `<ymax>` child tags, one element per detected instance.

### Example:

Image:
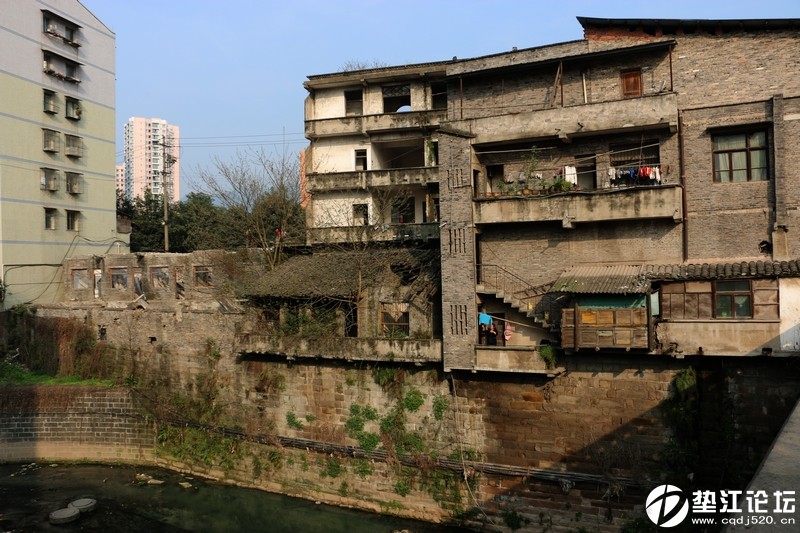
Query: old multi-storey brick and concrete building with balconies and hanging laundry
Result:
<box><xmin>306</xmin><ymin>18</ymin><xmax>800</xmax><ymax>372</ymax></box>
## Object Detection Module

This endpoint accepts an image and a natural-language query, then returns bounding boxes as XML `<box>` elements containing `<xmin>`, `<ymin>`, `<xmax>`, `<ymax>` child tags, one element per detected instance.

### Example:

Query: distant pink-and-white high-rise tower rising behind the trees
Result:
<box><xmin>124</xmin><ymin>117</ymin><xmax>181</xmax><ymax>202</ymax></box>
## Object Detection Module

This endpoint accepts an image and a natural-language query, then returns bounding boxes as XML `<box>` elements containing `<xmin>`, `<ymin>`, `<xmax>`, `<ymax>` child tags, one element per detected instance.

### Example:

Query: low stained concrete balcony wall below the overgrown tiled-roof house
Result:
<box><xmin>236</xmin><ymin>333</ymin><xmax>442</xmax><ymax>363</ymax></box>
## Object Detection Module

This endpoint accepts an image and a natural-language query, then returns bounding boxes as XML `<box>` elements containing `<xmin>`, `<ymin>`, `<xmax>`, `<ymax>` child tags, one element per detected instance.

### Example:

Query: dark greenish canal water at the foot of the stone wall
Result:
<box><xmin>0</xmin><ymin>463</ymin><xmax>470</xmax><ymax>533</ymax></box>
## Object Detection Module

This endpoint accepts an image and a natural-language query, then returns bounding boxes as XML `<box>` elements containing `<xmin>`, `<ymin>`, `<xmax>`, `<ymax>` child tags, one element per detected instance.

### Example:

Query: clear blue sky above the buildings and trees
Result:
<box><xmin>81</xmin><ymin>0</ymin><xmax>800</xmax><ymax>196</ymax></box>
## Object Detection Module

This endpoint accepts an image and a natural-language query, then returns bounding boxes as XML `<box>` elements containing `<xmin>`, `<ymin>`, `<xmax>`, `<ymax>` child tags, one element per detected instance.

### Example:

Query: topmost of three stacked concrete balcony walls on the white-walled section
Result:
<box><xmin>305</xmin><ymin>109</ymin><xmax>447</xmax><ymax>139</ymax></box>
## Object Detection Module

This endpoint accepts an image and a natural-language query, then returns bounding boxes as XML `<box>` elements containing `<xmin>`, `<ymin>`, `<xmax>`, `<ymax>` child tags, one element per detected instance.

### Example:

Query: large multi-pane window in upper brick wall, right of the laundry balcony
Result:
<box><xmin>712</xmin><ymin>130</ymin><xmax>769</xmax><ymax>183</ymax></box>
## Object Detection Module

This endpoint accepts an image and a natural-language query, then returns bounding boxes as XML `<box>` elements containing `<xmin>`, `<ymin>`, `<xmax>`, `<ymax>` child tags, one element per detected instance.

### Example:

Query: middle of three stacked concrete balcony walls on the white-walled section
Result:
<box><xmin>306</xmin><ymin>167</ymin><xmax>439</xmax><ymax>192</ymax></box>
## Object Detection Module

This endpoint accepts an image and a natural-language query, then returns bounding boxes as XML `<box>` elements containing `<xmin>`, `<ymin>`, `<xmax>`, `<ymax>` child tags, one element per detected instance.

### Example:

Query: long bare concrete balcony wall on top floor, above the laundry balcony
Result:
<box><xmin>450</xmin><ymin>93</ymin><xmax>678</xmax><ymax>145</ymax></box>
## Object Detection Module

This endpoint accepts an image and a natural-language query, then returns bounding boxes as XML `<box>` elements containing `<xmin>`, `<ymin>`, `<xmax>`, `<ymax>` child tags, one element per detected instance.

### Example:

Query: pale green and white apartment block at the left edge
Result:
<box><xmin>0</xmin><ymin>0</ymin><xmax>127</xmax><ymax>309</ymax></box>
